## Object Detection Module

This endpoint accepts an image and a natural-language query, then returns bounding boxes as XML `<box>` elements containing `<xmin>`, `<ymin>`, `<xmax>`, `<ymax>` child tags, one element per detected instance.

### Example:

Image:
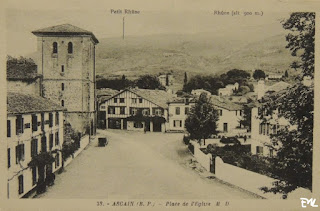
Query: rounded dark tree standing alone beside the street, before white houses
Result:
<box><xmin>185</xmin><ymin>93</ymin><xmax>219</xmax><ymax>144</ymax></box>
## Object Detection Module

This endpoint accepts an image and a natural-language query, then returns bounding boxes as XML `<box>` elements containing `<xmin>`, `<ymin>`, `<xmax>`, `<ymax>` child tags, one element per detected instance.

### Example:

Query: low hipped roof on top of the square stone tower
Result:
<box><xmin>32</xmin><ymin>24</ymin><xmax>99</xmax><ymax>43</ymax></box>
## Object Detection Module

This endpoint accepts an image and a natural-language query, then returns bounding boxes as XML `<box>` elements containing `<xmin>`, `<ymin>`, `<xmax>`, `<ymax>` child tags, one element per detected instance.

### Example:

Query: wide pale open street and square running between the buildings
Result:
<box><xmin>39</xmin><ymin>130</ymin><xmax>257</xmax><ymax>200</ymax></box>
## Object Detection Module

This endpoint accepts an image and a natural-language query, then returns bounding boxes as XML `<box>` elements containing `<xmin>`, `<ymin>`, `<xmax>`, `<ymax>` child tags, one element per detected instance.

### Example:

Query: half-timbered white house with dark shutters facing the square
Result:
<box><xmin>99</xmin><ymin>89</ymin><xmax>174</xmax><ymax>132</ymax></box>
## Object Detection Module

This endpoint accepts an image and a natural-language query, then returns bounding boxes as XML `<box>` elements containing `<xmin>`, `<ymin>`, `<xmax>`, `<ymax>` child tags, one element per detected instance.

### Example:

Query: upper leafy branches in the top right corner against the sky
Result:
<box><xmin>282</xmin><ymin>12</ymin><xmax>315</xmax><ymax>77</ymax></box>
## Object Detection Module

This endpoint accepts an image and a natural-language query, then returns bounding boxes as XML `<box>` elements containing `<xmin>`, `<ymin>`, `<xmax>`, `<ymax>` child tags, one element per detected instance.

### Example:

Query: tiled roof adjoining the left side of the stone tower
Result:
<box><xmin>7</xmin><ymin>64</ymin><xmax>41</xmax><ymax>80</ymax></box>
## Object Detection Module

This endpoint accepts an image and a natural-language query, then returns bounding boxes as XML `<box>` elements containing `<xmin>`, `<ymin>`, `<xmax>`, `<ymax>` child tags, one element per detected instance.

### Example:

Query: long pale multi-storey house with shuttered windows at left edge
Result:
<box><xmin>7</xmin><ymin>92</ymin><xmax>65</xmax><ymax>199</ymax></box>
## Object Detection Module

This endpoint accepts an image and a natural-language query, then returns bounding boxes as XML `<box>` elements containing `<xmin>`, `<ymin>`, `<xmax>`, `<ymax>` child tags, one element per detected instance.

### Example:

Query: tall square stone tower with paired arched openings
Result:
<box><xmin>32</xmin><ymin>24</ymin><xmax>99</xmax><ymax>135</ymax></box>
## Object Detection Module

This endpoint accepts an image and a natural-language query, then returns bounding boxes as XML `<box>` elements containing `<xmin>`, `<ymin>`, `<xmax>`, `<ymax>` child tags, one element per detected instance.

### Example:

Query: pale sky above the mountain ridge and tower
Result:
<box><xmin>5</xmin><ymin>0</ymin><xmax>318</xmax><ymax>56</ymax></box>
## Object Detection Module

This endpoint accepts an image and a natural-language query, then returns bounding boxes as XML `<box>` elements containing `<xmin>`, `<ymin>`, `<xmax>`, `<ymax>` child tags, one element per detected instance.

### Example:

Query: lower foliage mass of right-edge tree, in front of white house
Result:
<box><xmin>263</xmin><ymin>83</ymin><xmax>314</xmax><ymax>194</ymax></box>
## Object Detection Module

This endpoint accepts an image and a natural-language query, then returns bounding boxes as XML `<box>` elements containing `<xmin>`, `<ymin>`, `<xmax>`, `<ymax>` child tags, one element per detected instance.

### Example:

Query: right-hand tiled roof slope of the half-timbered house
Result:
<box><xmin>129</xmin><ymin>88</ymin><xmax>176</xmax><ymax>108</ymax></box>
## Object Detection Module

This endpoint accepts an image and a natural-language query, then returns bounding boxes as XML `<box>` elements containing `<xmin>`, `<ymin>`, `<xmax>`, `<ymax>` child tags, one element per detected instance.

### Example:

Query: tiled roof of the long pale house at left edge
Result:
<box><xmin>7</xmin><ymin>92</ymin><xmax>66</xmax><ymax>114</ymax></box>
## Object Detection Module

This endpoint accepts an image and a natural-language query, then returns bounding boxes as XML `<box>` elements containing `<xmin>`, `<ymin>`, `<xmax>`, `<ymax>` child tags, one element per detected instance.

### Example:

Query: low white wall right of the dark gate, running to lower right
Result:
<box><xmin>215</xmin><ymin>157</ymin><xmax>311</xmax><ymax>199</ymax></box>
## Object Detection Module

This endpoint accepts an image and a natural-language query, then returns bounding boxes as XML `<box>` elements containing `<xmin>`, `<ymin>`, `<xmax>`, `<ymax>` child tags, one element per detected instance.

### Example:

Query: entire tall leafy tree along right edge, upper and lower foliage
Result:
<box><xmin>262</xmin><ymin>12</ymin><xmax>315</xmax><ymax>194</ymax></box>
